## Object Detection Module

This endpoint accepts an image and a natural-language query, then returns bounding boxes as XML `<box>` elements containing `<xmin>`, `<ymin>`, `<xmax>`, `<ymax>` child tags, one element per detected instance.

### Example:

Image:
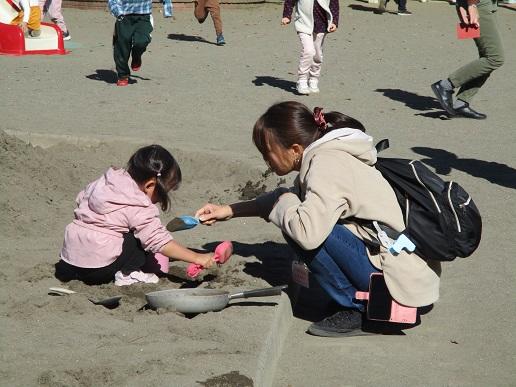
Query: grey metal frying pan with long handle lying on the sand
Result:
<box><xmin>145</xmin><ymin>285</ymin><xmax>287</xmax><ymax>313</ymax></box>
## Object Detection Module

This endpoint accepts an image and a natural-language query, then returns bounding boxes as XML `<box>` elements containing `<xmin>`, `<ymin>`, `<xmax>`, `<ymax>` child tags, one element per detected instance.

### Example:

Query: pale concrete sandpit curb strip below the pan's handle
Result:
<box><xmin>253</xmin><ymin>293</ymin><xmax>294</xmax><ymax>387</ymax></box>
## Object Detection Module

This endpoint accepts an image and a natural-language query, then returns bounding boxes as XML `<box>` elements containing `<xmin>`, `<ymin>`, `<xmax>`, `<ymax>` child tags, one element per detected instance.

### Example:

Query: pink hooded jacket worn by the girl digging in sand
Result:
<box><xmin>61</xmin><ymin>168</ymin><xmax>172</xmax><ymax>268</ymax></box>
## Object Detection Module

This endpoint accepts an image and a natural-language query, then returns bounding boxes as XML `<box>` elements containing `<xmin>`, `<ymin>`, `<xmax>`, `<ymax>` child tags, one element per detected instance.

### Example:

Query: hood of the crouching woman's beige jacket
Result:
<box><xmin>303</xmin><ymin>128</ymin><xmax>377</xmax><ymax>165</ymax></box>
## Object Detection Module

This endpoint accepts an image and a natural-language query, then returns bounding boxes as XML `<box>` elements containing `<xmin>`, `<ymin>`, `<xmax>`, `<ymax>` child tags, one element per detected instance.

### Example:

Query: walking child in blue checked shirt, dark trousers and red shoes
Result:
<box><xmin>108</xmin><ymin>0</ymin><xmax>172</xmax><ymax>86</ymax></box>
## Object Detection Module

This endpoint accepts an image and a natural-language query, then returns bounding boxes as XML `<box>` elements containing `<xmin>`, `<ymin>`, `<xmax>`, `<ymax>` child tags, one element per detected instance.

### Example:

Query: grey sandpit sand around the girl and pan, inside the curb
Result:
<box><xmin>0</xmin><ymin>131</ymin><xmax>294</xmax><ymax>386</ymax></box>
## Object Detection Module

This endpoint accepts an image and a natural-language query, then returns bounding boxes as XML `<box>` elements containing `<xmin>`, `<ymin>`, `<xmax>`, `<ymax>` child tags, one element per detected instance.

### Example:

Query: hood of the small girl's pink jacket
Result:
<box><xmin>85</xmin><ymin>168</ymin><xmax>152</xmax><ymax>214</ymax></box>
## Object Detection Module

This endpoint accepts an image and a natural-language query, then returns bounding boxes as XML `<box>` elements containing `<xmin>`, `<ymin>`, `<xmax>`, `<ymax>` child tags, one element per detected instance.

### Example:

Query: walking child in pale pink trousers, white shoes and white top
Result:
<box><xmin>281</xmin><ymin>0</ymin><xmax>339</xmax><ymax>95</ymax></box>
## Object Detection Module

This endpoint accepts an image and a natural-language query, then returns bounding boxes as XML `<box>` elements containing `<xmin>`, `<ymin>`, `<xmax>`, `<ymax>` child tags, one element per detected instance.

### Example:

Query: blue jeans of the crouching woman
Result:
<box><xmin>286</xmin><ymin>224</ymin><xmax>379</xmax><ymax>311</ymax></box>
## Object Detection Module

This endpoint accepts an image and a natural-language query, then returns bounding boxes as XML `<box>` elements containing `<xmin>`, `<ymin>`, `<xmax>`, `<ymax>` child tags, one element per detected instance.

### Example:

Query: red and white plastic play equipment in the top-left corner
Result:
<box><xmin>0</xmin><ymin>0</ymin><xmax>68</xmax><ymax>55</ymax></box>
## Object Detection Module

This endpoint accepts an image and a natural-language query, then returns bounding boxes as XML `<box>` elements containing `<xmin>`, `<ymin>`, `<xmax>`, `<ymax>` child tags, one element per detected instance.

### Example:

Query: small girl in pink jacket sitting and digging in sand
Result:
<box><xmin>56</xmin><ymin>145</ymin><xmax>214</xmax><ymax>286</ymax></box>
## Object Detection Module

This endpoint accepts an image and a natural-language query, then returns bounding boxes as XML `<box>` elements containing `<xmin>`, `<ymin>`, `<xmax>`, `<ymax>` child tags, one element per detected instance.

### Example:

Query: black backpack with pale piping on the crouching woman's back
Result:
<box><xmin>375</xmin><ymin>140</ymin><xmax>482</xmax><ymax>261</ymax></box>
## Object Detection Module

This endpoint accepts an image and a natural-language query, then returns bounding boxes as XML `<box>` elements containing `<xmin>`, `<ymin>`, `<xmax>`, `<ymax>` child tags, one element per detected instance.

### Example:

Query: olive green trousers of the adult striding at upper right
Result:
<box><xmin>449</xmin><ymin>4</ymin><xmax>504</xmax><ymax>103</ymax></box>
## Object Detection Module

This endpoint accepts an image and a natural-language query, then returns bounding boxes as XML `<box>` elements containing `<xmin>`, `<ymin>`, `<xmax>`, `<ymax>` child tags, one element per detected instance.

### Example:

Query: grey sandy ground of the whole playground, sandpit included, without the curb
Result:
<box><xmin>0</xmin><ymin>0</ymin><xmax>516</xmax><ymax>387</ymax></box>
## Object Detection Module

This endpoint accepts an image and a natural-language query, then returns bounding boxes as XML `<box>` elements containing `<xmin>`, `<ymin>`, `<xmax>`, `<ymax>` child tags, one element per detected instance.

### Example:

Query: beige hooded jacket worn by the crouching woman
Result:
<box><xmin>257</xmin><ymin>128</ymin><xmax>441</xmax><ymax>306</ymax></box>
